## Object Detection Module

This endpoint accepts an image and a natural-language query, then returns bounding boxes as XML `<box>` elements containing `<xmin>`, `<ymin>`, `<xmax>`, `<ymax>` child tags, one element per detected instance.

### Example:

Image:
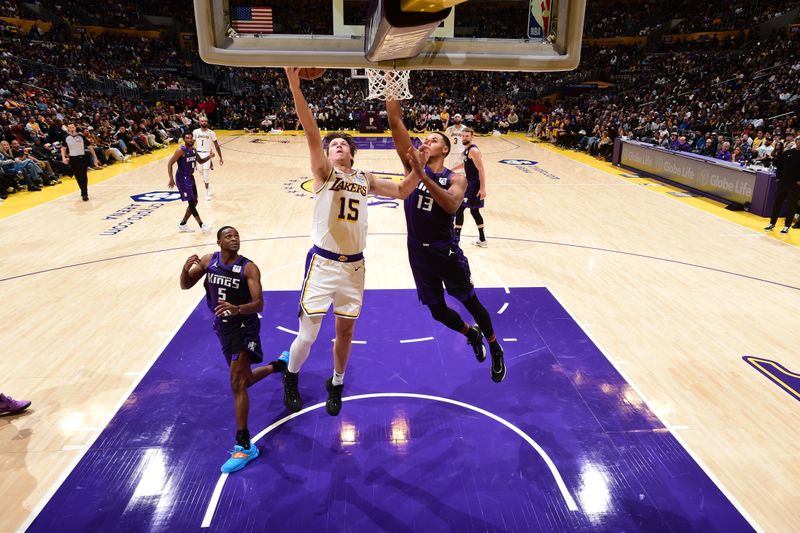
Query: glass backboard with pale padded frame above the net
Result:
<box><xmin>194</xmin><ymin>0</ymin><xmax>586</xmax><ymax>71</ymax></box>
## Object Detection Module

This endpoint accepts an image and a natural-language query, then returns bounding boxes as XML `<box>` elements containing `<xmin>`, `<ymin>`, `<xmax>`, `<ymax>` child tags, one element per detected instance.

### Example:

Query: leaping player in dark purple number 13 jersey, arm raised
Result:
<box><xmin>386</xmin><ymin>99</ymin><xmax>506</xmax><ymax>383</ymax></box>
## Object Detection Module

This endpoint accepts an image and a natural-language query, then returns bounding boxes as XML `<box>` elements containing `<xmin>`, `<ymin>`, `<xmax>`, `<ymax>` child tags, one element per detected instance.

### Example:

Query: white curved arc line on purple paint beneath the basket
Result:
<box><xmin>200</xmin><ymin>392</ymin><xmax>579</xmax><ymax>528</ymax></box>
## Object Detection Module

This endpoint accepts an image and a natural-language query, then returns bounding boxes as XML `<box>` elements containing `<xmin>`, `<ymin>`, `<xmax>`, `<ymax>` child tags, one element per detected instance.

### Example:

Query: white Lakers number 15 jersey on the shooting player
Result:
<box><xmin>311</xmin><ymin>169</ymin><xmax>369</xmax><ymax>255</ymax></box>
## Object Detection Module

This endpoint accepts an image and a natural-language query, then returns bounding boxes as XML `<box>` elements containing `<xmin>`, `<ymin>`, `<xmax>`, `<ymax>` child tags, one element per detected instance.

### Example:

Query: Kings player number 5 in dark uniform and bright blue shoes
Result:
<box><xmin>181</xmin><ymin>226</ymin><xmax>289</xmax><ymax>473</ymax></box>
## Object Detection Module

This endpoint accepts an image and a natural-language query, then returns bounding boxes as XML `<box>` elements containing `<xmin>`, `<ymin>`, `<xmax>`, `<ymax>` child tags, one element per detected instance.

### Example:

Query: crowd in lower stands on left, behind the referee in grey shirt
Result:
<box><xmin>0</xmin><ymin>80</ymin><xmax>209</xmax><ymax>199</ymax></box>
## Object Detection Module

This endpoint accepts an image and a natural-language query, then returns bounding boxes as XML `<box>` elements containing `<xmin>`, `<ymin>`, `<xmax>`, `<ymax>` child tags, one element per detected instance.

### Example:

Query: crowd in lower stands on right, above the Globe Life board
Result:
<box><xmin>530</xmin><ymin>33</ymin><xmax>800</xmax><ymax>166</ymax></box>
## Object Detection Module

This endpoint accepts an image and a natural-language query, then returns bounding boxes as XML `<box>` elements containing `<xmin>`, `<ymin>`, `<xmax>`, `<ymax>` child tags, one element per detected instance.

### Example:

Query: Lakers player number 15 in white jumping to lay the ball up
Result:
<box><xmin>283</xmin><ymin>68</ymin><xmax>419</xmax><ymax>416</ymax></box>
